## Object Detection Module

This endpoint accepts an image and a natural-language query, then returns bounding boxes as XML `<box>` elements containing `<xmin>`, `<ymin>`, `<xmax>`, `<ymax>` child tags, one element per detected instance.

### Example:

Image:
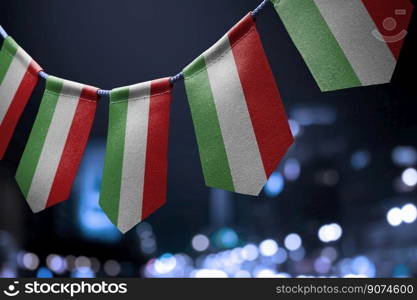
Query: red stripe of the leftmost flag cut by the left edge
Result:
<box><xmin>0</xmin><ymin>61</ymin><xmax>42</xmax><ymax>160</ymax></box>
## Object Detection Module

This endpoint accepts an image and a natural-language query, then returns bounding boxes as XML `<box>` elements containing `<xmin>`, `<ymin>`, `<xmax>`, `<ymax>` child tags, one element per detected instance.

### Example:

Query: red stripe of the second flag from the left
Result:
<box><xmin>46</xmin><ymin>86</ymin><xmax>98</xmax><ymax>208</ymax></box>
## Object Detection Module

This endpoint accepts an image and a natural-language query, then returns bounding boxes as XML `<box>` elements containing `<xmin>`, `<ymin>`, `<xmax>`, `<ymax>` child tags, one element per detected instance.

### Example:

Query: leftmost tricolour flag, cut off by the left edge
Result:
<box><xmin>0</xmin><ymin>36</ymin><xmax>42</xmax><ymax>159</ymax></box>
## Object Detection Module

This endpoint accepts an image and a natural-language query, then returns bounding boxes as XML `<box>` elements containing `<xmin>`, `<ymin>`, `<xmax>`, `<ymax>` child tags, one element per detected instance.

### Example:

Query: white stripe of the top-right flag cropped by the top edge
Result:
<box><xmin>314</xmin><ymin>0</ymin><xmax>396</xmax><ymax>85</ymax></box>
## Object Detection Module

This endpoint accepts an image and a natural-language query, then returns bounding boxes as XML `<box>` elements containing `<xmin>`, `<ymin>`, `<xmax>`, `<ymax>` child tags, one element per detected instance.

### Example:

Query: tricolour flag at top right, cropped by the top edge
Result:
<box><xmin>272</xmin><ymin>0</ymin><xmax>413</xmax><ymax>91</ymax></box>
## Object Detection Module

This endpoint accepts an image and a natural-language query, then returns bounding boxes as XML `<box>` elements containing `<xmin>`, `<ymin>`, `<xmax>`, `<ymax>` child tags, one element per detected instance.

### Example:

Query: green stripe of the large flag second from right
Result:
<box><xmin>184</xmin><ymin>56</ymin><xmax>234</xmax><ymax>191</ymax></box>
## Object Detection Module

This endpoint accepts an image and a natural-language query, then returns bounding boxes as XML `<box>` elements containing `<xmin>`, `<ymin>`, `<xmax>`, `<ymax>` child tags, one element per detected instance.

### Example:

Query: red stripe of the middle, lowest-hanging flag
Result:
<box><xmin>142</xmin><ymin>78</ymin><xmax>171</xmax><ymax>220</ymax></box>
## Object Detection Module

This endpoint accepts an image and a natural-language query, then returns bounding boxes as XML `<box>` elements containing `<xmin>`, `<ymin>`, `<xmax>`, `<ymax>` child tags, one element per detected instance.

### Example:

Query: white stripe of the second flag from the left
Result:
<box><xmin>27</xmin><ymin>82</ymin><xmax>82</xmax><ymax>212</ymax></box>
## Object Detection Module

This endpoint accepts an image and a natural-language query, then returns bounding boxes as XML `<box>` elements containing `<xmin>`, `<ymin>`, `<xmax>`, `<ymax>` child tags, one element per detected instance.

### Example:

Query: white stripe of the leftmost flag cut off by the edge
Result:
<box><xmin>0</xmin><ymin>48</ymin><xmax>31</xmax><ymax>124</ymax></box>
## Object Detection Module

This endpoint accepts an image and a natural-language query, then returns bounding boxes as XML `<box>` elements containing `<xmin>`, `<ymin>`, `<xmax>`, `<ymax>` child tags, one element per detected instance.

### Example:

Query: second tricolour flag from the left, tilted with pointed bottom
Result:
<box><xmin>16</xmin><ymin>76</ymin><xmax>98</xmax><ymax>213</ymax></box>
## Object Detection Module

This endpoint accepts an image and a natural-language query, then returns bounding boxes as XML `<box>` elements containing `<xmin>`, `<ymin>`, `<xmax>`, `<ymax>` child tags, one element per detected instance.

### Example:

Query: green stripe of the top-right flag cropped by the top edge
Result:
<box><xmin>272</xmin><ymin>0</ymin><xmax>362</xmax><ymax>91</ymax></box>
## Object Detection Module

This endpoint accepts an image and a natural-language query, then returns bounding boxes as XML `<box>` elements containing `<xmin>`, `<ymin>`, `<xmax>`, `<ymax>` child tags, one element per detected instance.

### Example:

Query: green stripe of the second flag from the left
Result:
<box><xmin>16</xmin><ymin>76</ymin><xmax>63</xmax><ymax>197</ymax></box>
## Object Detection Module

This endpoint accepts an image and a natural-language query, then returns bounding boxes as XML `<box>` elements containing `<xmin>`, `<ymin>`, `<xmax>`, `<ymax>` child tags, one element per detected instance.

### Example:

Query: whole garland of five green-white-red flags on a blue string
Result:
<box><xmin>0</xmin><ymin>0</ymin><xmax>413</xmax><ymax>233</ymax></box>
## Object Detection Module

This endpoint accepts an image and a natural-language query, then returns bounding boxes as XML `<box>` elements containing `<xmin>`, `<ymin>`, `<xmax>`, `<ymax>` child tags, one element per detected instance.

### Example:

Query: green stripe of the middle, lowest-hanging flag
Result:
<box><xmin>100</xmin><ymin>88</ymin><xmax>128</xmax><ymax>226</ymax></box>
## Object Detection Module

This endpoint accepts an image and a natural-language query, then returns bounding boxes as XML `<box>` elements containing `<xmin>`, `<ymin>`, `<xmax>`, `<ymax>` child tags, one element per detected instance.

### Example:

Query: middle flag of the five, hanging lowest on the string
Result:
<box><xmin>100</xmin><ymin>78</ymin><xmax>172</xmax><ymax>233</ymax></box>
